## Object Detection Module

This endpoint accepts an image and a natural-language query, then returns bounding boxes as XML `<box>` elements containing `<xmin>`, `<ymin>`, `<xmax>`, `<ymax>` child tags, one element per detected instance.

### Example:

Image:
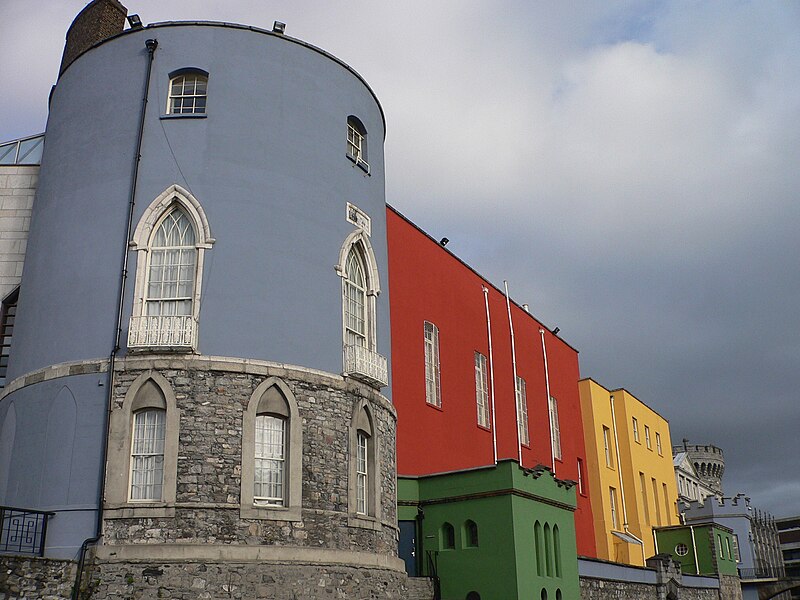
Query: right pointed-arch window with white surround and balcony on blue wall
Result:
<box><xmin>336</xmin><ymin>229</ymin><xmax>389</xmax><ymax>388</ymax></box>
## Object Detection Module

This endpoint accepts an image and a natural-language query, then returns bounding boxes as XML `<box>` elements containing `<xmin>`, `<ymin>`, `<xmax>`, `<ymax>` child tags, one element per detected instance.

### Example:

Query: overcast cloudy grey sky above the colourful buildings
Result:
<box><xmin>0</xmin><ymin>0</ymin><xmax>800</xmax><ymax>517</ymax></box>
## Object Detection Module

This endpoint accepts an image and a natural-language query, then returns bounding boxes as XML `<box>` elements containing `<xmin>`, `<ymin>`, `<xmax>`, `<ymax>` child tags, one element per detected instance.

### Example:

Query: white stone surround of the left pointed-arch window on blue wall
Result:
<box><xmin>130</xmin><ymin>185</ymin><xmax>216</xmax><ymax>351</ymax></box>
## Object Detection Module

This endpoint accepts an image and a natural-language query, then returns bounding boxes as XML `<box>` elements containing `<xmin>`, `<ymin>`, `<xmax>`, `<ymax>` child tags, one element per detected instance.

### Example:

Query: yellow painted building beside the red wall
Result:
<box><xmin>578</xmin><ymin>379</ymin><xmax>679</xmax><ymax>566</ymax></box>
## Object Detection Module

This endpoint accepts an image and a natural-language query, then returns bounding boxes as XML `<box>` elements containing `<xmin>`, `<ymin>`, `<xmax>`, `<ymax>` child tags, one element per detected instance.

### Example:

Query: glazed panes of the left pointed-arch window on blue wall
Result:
<box><xmin>145</xmin><ymin>206</ymin><xmax>197</xmax><ymax>317</ymax></box>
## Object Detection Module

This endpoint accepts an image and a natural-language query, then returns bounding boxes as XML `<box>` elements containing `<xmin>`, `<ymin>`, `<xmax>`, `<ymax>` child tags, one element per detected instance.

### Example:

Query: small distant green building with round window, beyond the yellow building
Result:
<box><xmin>654</xmin><ymin>523</ymin><xmax>738</xmax><ymax>576</ymax></box>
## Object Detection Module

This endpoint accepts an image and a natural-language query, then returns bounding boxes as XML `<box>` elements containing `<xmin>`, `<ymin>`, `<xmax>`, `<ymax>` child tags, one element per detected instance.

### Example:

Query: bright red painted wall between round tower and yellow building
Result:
<box><xmin>387</xmin><ymin>207</ymin><xmax>595</xmax><ymax>556</ymax></box>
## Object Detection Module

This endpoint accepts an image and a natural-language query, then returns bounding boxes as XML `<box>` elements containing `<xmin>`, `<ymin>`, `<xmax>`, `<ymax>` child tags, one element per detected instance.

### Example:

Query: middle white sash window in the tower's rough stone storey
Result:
<box><xmin>253</xmin><ymin>415</ymin><xmax>286</xmax><ymax>506</ymax></box>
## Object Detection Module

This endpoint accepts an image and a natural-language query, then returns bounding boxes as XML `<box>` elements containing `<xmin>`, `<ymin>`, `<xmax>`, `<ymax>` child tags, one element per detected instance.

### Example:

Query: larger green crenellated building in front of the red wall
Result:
<box><xmin>398</xmin><ymin>460</ymin><xmax>580</xmax><ymax>600</ymax></box>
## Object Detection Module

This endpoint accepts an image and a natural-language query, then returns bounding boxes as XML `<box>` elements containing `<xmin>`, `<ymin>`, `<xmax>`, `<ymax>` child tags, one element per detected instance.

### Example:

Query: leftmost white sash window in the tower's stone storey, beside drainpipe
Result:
<box><xmin>131</xmin><ymin>408</ymin><xmax>166</xmax><ymax>500</ymax></box>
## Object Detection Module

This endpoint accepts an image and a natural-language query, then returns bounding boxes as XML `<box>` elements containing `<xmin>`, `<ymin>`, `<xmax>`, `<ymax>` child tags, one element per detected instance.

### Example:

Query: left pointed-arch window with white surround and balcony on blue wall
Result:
<box><xmin>128</xmin><ymin>185</ymin><xmax>214</xmax><ymax>351</ymax></box>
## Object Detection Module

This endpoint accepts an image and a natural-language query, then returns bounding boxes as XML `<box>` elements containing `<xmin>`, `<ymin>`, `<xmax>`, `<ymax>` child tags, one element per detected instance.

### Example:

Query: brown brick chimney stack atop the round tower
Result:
<box><xmin>58</xmin><ymin>0</ymin><xmax>128</xmax><ymax>77</ymax></box>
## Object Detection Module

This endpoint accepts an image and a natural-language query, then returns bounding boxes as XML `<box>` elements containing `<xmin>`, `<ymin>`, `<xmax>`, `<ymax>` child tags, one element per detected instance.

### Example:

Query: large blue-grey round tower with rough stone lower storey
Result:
<box><xmin>0</xmin><ymin>0</ymin><xmax>404</xmax><ymax>598</ymax></box>
